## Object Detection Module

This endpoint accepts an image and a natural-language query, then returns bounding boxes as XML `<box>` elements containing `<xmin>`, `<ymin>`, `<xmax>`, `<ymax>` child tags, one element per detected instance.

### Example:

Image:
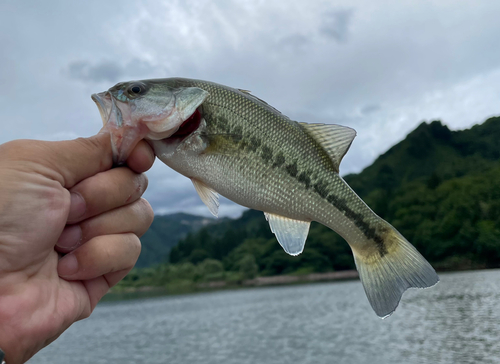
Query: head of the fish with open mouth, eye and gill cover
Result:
<box><xmin>92</xmin><ymin>79</ymin><xmax>208</xmax><ymax>164</ymax></box>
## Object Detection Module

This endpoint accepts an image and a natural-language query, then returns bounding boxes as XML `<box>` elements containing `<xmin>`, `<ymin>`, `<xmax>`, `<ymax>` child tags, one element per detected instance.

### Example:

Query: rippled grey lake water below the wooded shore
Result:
<box><xmin>29</xmin><ymin>270</ymin><xmax>500</xmax><ymax>364</ymax></box>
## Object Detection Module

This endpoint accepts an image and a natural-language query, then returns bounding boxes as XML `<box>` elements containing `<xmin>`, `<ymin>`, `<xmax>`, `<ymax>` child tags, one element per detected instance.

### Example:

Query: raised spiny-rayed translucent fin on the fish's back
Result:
<box><xmin>299</xmin><ymin>123</ymin><xmax>356</xmax><ymax>173</ymax></box>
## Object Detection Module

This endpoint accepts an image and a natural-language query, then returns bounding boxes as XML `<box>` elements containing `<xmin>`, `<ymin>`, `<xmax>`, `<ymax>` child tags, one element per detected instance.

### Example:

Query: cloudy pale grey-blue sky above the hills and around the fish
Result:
<box><xmin>0</xmin><ymin>0</ymin><xmax>500</xmax><ymax>217</ymax></box>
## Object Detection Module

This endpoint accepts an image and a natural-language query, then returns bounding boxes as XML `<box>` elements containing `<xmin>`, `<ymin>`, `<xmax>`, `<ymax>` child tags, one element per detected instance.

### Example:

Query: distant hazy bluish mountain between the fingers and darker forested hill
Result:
<box><xmin>140</xmin><ymin>213</ymin><xmax>220</xmax><ymax>268</ymax></box>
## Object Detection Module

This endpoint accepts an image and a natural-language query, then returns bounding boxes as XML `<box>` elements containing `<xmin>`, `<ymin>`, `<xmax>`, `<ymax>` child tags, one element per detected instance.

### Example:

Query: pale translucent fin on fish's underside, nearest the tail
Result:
<box><xmin>264</xmin><ymin>212</ymin><xmax>311</xmax><ymax>255</ymax></box>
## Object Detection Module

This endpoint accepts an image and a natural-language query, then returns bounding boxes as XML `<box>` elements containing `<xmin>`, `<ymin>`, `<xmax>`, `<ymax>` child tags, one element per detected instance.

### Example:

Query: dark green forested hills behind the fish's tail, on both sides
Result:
<box><xmin>166</xmin><ymin>117</ymin><xmax>500</xmax><ymax>275</ymax></box>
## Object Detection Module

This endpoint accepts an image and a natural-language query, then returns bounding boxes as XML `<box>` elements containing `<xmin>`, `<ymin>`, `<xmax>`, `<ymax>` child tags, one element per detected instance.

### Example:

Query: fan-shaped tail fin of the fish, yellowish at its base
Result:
<box><xmin>353</xmin><ymin>230</ymin><xmax>439</xmax><ymax>318</ymax></box>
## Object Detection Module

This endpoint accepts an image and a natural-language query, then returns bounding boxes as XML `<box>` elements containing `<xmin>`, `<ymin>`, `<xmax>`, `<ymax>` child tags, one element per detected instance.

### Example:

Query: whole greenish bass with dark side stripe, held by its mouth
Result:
<box><xmin>92</xmin><ymin>78</ymin><xmax>439</xmax><ymax>318</ymax></box>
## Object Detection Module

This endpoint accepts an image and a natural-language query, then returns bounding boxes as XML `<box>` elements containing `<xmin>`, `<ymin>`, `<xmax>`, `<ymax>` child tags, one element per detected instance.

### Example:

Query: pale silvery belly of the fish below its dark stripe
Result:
<box><xmin>157</xmin><ymin>144</ymin><xmax>378</xmax><ymax>248</ymax></box>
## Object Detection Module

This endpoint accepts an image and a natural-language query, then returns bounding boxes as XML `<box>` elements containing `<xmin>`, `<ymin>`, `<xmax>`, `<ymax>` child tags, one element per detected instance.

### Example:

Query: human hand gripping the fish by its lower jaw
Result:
<box><xmin>0</xmin><ymin>133</ymin><xmax>154</xmax><ymax>364</ymax></box>
